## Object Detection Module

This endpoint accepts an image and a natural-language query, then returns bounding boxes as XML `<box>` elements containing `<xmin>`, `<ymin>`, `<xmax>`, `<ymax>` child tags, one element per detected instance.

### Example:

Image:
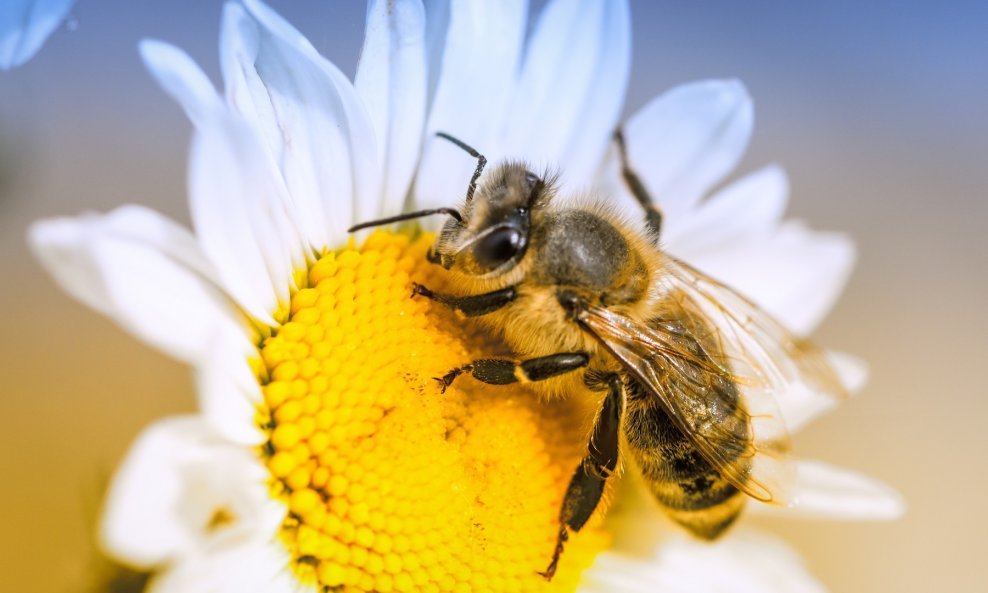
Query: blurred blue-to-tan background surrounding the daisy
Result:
<box><xmin>0</xmin><ymin>0</ymin><xmax>988</xmax><ymax>593</ymax></box>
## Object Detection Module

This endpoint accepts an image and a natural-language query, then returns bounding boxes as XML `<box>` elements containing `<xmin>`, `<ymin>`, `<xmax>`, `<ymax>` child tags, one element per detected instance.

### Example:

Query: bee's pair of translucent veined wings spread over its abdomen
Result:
<box><xmin>577</xmin><ymin>258</ymin><xmax>843</xmax><ymax>504</ymax></box>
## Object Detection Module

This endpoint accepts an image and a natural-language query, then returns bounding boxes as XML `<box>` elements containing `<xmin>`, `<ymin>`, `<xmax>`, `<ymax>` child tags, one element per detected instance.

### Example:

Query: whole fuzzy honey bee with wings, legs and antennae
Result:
<box><xmin>351</xmin><ymin>130</ymin><xmax>844</xmax><ymax>579</ymax></box>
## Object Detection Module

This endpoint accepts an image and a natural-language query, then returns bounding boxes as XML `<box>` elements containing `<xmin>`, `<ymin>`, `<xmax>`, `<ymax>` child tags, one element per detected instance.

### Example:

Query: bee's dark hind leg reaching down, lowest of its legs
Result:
<box><xmin>539</xmin><ymin>374</ymin><xmax>624</xmax><ymax>580</ymax></box>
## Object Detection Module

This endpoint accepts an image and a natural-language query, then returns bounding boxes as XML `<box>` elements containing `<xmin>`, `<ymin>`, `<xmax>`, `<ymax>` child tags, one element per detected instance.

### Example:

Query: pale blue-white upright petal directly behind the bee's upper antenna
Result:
<box><xmin>415</xmin><ymin>0</ymin><xmax>528</xmax><ymax>208</ymax></box>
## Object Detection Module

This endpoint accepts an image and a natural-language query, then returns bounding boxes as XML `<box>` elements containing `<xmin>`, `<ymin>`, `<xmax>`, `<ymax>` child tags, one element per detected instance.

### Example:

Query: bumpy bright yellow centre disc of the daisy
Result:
<box><xmin>259</xmin><ymin>231</ymin><xmax>608</xmax><ymax>593</ymax></box>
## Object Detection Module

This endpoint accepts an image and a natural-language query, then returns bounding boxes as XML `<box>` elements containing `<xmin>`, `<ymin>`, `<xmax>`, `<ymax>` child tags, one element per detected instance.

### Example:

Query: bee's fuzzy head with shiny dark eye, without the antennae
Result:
<box><xmin>430</xmin><ymin>162</ymin><xmax>552</xmax><ymax>277</ymax></box>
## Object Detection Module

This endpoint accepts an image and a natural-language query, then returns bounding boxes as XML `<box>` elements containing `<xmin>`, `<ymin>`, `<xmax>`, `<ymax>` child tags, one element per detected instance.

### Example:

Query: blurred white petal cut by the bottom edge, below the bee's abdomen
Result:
<box><xmin>578</xmin><ymin>529</ymin><xmax>824</xmax><ymax>593</ymax></box>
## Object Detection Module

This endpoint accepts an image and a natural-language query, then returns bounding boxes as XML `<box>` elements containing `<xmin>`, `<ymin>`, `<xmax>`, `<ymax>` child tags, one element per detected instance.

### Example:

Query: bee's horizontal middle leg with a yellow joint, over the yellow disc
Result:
<box><xmin>436</xmin><ymin>352</ymin><xmax>590</xmax><ymax>392</ymax></box>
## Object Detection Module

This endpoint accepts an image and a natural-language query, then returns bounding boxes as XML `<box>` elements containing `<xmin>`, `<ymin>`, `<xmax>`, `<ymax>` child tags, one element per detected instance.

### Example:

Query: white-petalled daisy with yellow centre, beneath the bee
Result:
<box><xmin>30</xmin><ymin>0</ymin><xmax>901</xmax><ymax>593</ymax></box>
